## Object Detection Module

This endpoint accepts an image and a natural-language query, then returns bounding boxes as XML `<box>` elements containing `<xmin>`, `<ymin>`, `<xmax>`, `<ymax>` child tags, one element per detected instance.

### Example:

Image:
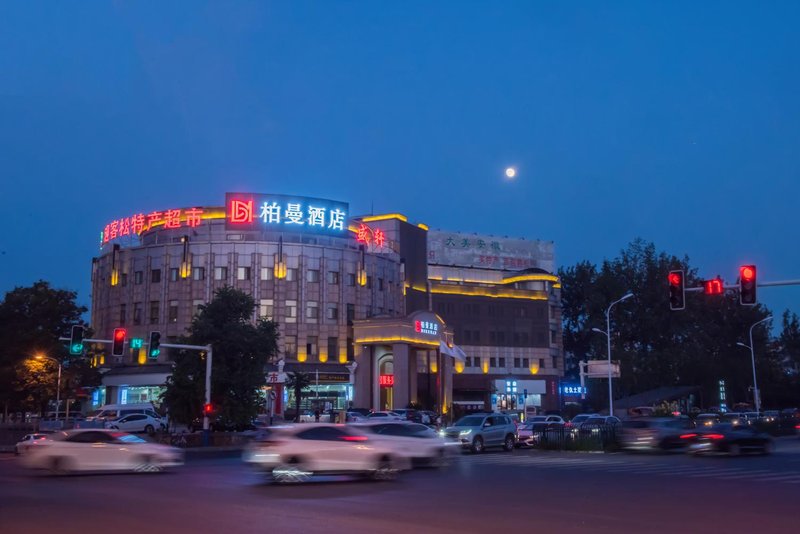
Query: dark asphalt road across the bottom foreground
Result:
<box><xmin>0</xmin><ymin>439</ymin><xmax>800</xmax><ymax>534</ymax></box>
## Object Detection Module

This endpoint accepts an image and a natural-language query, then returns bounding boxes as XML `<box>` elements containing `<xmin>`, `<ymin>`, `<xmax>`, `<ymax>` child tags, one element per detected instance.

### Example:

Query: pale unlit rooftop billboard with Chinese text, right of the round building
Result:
<box><xmin>428</xmin><ymin>230</ymin><xmax>556</xmax><ymax>273</ymax></box>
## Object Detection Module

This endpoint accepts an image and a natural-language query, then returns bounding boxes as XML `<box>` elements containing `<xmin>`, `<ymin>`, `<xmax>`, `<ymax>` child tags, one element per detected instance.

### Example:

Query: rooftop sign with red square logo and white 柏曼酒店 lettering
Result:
<box><xmin>225</xmin><ymin>193</ymin><xmax>349</xmax><ymax>236</ymax></box>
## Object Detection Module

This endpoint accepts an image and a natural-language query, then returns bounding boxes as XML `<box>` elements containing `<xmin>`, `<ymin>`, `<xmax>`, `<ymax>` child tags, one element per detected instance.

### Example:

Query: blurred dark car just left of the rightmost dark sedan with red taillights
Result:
<box><xmin>619</xmin><ymin>417</ymin><xmax>694</xmax><ymax>451</ymax></box>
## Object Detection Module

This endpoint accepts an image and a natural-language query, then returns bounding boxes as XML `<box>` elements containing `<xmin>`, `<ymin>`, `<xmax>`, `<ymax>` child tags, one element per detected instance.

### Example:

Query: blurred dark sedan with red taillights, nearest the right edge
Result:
<box><xmin>686</xmin><ymin>423</ymin><xmax>775</xmax><ymax>456</ymax></box>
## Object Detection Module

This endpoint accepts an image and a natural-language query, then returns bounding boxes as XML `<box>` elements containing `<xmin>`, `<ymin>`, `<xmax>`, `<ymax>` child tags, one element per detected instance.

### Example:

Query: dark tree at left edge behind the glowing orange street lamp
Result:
<box><xmin>0</xmin><ymin>280</ymin><xmax>87</xmax><ymax>416</ymax></box>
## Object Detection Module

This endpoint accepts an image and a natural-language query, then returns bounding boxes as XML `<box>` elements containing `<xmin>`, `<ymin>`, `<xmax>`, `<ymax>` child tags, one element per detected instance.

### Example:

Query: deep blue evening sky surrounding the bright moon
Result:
<box><xmin>0</xmin><ymin>1</ymin><xmax>800</xmax><ymax>322</ymax></box>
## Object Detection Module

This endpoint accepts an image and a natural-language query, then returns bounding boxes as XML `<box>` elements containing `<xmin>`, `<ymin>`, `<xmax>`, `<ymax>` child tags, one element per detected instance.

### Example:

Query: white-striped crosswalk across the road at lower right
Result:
<box><xmin>459</xmin><ymin>454</ymin><xmax>800</xmax><ymax>484</ymax></box>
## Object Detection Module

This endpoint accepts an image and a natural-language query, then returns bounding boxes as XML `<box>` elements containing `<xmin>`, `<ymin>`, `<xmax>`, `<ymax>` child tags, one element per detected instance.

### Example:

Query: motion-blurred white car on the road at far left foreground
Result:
<box><xmin>21</xmin><ymin>428</ymin><xmax>183</xmax><ymax>474</ymax></box>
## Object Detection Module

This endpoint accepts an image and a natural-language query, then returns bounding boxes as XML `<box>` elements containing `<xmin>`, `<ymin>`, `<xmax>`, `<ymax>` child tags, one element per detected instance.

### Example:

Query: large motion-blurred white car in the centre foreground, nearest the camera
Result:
<box><xmin>242</xmin><ymin>423</ymin><xmax>408</xmax><ymax>483</ymax></box>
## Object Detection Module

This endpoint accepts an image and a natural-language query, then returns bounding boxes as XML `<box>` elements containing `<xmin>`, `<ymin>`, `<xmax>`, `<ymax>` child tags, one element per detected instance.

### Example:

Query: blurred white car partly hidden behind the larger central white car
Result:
<box><xmin>353</xmin><ymin>421</ymin><xmax>458</xmax><ymax>467</ymax></box>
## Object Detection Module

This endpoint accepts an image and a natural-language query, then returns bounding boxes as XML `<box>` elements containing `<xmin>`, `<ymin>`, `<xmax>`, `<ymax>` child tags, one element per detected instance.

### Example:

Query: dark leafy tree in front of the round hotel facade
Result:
<box><xmin>162</xmin><ymin>287</ymin><xmax>278</xmax><ymax>426</ymax></box>
